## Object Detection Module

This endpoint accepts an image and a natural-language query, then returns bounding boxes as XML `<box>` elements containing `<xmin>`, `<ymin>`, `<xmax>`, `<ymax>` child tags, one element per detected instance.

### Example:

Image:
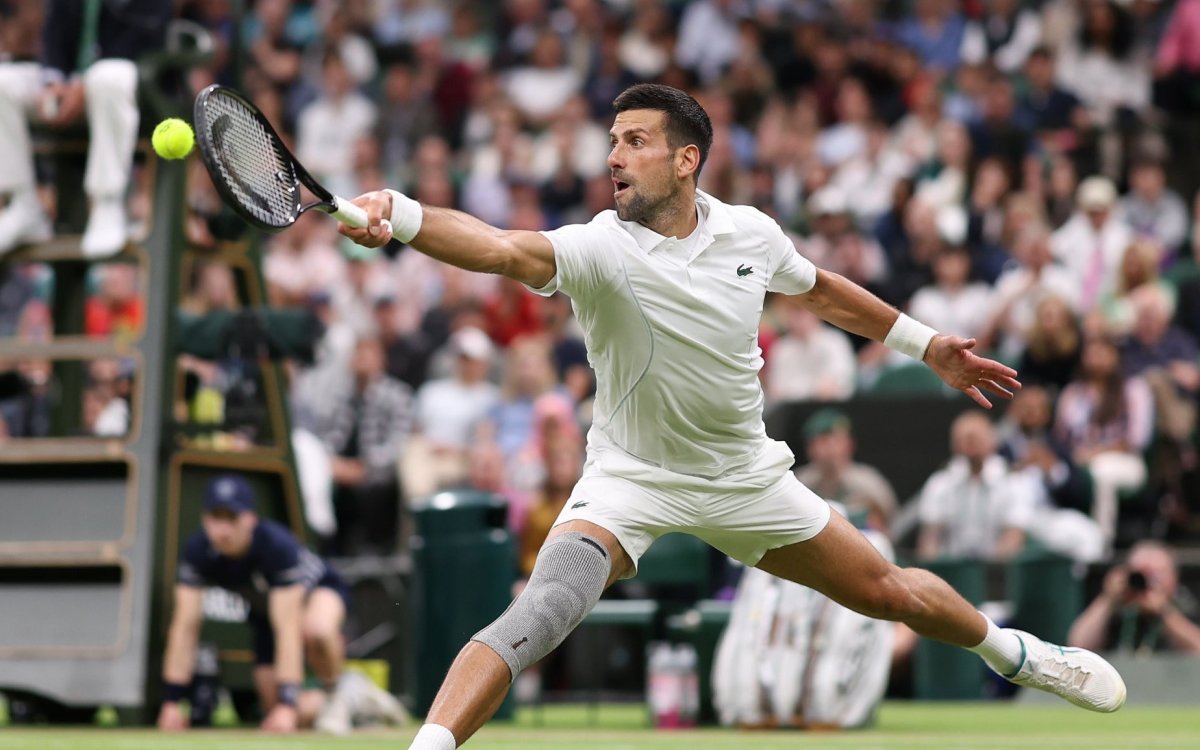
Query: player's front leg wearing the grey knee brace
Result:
<box><xmin>410</xmin><ymin>521</ymin><xmax>632</xmax><ymax>750</ymax></box>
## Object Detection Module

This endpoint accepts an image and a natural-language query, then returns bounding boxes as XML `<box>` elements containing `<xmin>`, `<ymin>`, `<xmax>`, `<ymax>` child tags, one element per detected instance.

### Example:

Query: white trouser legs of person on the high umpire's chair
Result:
<box><xmin>0</xmin><ymin>59</ymin><xmax>138</xmax><ymax>198</ymax></box>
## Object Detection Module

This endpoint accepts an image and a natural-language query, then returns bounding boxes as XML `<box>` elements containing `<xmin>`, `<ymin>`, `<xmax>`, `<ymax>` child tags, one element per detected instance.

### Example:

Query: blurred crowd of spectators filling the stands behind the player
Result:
<box><xmin>0</xmin><ymin>0</ymin><xmax>1200</xmax><ymax>559</ymax></box>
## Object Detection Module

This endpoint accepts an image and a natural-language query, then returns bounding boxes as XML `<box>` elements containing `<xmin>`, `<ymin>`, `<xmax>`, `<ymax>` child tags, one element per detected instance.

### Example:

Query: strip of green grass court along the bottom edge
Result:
<box><xmin>0</xmin><ymin>703</ymin><xmax>1200</xmax><ymax>750</ymax></box>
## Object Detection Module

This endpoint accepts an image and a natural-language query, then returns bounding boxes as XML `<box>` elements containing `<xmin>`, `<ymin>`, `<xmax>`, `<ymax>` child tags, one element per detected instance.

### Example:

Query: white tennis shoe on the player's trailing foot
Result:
<box><xmin>1002</xmin><ymin>629</ymin><xmax>1126</xmax><ymax>713</ymax></box>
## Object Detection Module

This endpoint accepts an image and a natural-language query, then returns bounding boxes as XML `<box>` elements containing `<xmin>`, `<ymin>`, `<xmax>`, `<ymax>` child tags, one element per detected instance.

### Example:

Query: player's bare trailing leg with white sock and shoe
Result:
<box><xmin>758</xmin><ymin>506</ymin><xmax>1126</xmax><ymax>712</ymax></box>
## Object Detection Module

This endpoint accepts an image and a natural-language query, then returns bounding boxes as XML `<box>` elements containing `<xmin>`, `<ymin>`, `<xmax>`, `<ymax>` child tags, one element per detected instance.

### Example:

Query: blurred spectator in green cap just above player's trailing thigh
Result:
<box><xmin>796</xmin><ymin>408</ymin><xmax>896</xmax><ymax>532</ymax></box>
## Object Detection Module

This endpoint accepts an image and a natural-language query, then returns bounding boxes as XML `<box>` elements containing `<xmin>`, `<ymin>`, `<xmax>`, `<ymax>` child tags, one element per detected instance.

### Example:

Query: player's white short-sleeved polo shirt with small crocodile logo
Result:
<box><xmin>534</xmin><ymin>192</ymin><xmax>816</xmax><ymax>479</ymax></box>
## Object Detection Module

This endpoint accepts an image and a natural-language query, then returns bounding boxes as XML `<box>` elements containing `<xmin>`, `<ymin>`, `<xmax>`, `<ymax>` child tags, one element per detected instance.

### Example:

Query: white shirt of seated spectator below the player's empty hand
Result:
<box><xmin>919</xmin><ymin>456</ymin><xmax>1042</xmax><ymax>559</ymax></box>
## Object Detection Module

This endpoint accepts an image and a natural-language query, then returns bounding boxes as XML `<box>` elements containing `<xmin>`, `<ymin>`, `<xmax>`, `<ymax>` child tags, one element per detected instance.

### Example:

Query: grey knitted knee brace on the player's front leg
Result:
<box><xmin>472</xmin><ymin>532</ymin><xmax>612</xmax><ymax>679</ymax></box>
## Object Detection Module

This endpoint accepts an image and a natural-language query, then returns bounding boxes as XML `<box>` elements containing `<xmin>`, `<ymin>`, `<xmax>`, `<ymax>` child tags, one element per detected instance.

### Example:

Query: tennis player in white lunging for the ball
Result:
<box><xmin>340</xmin><ymin>84</ymin><xmax>1126</xmax><ymax>750</ymax></box>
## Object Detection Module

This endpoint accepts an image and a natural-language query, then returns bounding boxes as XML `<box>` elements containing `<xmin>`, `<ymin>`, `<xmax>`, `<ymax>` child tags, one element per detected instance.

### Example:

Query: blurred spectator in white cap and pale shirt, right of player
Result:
<box><xmin>1050</xmin><ymin>176</ymin><xmax>1133</xmax><ymax>310</ymax></box>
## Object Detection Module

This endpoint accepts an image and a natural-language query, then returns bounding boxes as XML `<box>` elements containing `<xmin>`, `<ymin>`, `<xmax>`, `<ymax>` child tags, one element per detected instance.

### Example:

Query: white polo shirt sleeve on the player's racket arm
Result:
<box><xmin>529</xmin><ymin>218</ymin><xmax>619</xmax><ymax>300</ymax></box>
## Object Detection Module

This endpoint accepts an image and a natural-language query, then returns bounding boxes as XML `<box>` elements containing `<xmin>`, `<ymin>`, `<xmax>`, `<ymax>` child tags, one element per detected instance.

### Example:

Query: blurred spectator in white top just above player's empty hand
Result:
<box><xmin>908</xmin><ymin>245</ymin><xmax>991</xmax><ymax>338</ymax></box>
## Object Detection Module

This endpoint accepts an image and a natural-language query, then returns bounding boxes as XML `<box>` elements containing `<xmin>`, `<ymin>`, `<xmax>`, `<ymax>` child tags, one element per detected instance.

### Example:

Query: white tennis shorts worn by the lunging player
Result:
<box><xmin>554</xmin><ymin>456</ymin><xmax>829</xmax><ymax>577</ymax></box>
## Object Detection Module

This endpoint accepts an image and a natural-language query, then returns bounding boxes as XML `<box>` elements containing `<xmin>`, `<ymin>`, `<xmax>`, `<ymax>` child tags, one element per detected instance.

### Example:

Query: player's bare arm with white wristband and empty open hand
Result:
<box><xmin>797</xmin><ymin>270</ymin><xmax>1021</xmax><ymax>409</ymax></box>
